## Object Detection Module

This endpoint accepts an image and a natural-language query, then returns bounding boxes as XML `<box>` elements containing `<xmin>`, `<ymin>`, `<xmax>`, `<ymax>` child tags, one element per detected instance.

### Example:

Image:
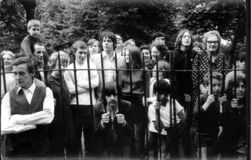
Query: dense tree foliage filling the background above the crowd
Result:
<box><xmin>0</xmin><ymin>0</ymin><xmax>246</xmax><ymax>54</ymax></box>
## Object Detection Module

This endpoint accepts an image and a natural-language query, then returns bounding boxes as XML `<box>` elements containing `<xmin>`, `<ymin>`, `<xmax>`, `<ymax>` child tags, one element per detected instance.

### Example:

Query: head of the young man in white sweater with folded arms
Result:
<box><xmin>72</xmin><ymin>40</ymin><xmax>88</xmax><ymax>64</ymax></box>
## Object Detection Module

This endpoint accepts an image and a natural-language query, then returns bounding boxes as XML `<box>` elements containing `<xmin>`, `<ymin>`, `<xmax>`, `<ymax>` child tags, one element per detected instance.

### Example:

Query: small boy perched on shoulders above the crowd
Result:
<box><xmin>21</xmin><ymin>19</ymin><xmax>41</xmax><ymax>57</ymax></box>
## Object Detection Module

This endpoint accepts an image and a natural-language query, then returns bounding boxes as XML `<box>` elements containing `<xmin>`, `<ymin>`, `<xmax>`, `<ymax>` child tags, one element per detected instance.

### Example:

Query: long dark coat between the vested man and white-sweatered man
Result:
<box><xmin>48</xmin><ymin>75</ymin><xmax>75</xmax><ymax>156</ymax></box>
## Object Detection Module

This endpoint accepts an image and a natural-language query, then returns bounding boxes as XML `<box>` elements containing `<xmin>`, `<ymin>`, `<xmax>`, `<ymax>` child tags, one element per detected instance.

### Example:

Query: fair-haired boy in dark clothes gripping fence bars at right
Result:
<box><xmin>194</xmin><ymin>72</ymin><xmax>226</xmax><ymax>160</ymax></box>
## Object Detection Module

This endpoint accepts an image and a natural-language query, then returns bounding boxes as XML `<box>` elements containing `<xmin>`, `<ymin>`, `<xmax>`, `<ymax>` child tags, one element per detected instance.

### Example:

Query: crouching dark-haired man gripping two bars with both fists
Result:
<box><xmin>94</xmin><ymin>82</ymin><xmax>133</xmax><ymax>158</ymax></box>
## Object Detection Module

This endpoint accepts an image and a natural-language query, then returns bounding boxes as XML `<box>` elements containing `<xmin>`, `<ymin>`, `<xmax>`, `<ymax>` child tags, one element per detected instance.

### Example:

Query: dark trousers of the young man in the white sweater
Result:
<box><xmin>71</xmin><ymin>105</ymin><xmax>94</xmax><ymax>156</ymax></box>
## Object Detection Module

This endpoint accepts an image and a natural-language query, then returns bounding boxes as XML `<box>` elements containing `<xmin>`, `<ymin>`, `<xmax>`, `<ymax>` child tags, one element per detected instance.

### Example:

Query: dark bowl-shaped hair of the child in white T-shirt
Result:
<box><xmin>153</xmin><ymin>79</ymin><xmax>171</xmax><ymax>95</ymax></box>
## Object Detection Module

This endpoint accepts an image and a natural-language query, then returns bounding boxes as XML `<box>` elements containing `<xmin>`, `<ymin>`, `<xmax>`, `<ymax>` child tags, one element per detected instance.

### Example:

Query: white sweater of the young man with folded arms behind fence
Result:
<box><xmin>64</xmin><ymin>61</ymin><xmax>99</xmax><ymax>105</ymax></box>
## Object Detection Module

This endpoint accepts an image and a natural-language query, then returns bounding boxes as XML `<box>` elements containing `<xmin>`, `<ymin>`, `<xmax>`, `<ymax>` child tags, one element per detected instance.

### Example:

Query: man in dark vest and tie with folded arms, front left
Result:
<box><xmin>1</xmin><ymin>57</ymin><xmax>54</xmax><ymax>158</ymax></box>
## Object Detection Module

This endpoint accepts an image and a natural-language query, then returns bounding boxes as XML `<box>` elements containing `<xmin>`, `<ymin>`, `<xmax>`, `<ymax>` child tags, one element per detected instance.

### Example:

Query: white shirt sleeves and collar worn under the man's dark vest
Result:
<box><xmin>1</xmin><ymin>82</ymin><xmax>54</xmax><ymax>135</ymax></box>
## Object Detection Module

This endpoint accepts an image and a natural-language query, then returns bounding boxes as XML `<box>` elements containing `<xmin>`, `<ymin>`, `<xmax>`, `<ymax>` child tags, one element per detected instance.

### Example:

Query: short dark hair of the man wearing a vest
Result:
<box><xmin>12</xmin><ymin>56</ymin><xmax>35</xmax><ymax>74</ymax></box>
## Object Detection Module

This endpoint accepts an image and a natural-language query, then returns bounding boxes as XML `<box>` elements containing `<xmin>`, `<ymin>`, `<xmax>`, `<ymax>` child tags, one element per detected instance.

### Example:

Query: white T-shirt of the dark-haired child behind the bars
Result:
<box><xmin>148</xmin><ymin>96</ymin><xmax>183</xmax><ymax>135</ymax></box>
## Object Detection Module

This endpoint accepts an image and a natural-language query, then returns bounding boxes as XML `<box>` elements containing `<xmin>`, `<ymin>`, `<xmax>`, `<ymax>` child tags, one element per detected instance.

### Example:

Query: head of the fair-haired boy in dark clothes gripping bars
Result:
<box><xmin>204</xmin><ymin>72</ymin><xmax>222</xmax><ymax>95</ymax></box>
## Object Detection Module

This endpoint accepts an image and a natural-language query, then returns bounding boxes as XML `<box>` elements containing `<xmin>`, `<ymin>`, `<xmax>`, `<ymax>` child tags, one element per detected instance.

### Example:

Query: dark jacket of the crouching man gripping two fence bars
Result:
<box><xmin>94</xmin><ymin>100</ymin><xmax>133</xmax><ymax>155</ymax></box>
